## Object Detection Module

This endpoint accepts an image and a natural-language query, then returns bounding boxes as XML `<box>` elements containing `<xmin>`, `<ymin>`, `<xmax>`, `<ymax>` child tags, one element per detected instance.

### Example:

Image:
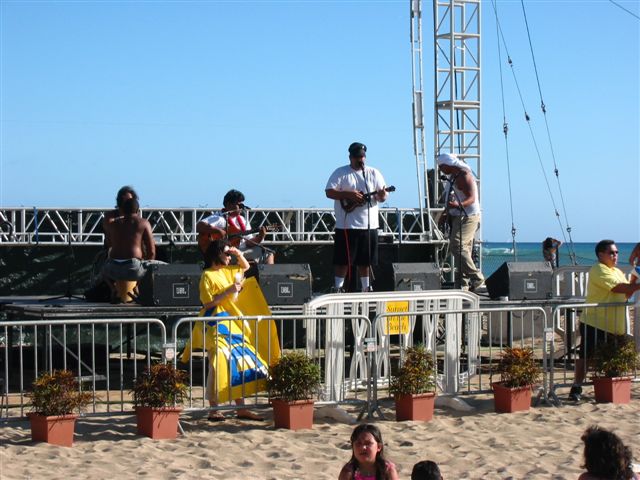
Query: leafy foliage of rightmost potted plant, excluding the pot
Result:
<box><xmin>591</xmin><ymin>335</ymin><xmax>640</xmax><ymax>378</ymax></box>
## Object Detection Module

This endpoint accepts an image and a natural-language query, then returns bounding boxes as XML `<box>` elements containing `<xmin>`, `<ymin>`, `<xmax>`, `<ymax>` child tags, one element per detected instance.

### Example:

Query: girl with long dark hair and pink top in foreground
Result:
<box><xmin>338</xmin><ymin>423</ymin><xmax>398</xmax><ymax>480</ymax></box>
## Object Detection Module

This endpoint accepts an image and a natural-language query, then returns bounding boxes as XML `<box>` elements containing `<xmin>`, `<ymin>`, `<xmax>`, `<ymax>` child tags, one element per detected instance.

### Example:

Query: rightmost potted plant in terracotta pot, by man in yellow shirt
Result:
<box><xmin>591</xmin><ymin>335</ymin><xmax>640</xmax><ymax>403</ymax></box>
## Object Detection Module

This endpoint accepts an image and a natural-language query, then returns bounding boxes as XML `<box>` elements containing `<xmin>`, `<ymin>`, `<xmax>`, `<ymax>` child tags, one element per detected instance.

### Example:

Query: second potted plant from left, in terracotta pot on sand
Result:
<box><xmin>131</xmin><ymin>363</ymin><xmax>189</xmax><ymax>440</ymax></box>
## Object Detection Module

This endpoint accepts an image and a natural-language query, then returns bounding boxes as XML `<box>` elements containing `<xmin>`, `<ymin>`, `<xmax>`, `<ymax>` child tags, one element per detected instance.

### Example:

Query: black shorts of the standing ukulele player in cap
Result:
<box><xmin>333</xmin><ymin>228</ymin><xmax>378</xmax><ymax>267</ymax></box>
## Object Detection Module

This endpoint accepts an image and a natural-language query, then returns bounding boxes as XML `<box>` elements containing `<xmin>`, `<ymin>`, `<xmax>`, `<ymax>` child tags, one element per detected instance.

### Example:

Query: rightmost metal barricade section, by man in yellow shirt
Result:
<box><xmin>549</xmin><ymin>303</ymin><xmax>640</xmax><ymax>404</ymax></box>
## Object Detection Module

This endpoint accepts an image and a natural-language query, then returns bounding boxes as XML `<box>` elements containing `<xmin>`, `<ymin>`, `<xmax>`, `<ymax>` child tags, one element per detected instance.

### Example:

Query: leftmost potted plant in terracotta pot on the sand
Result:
<box><xmin>27</xmin><ymin>370</ymin><xmax>93</xmax><ymax>447</ymax></box>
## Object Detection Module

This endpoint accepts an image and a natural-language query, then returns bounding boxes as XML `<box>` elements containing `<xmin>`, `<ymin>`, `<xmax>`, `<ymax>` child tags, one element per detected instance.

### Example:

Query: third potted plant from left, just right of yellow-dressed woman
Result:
<box><xmin>267</xmin><ymin>351</ymin><xmax>320</xmax><ymax>430</ymax></box>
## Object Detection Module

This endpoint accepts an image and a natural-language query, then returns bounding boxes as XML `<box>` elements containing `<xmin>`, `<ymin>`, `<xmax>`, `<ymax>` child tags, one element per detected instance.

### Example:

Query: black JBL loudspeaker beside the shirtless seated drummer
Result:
<box><xmin>137</xmin><ymin>263</ymin><xmax>202</xmax><ymax>307</ymax></box>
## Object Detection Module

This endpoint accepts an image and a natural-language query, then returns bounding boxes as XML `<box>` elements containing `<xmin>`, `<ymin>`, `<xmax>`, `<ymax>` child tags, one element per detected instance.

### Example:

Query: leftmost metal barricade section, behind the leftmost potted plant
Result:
<box><xmin>0</xmin><ymin>318</ymin><xmax>167</xmax><ymax>418</ymax></box>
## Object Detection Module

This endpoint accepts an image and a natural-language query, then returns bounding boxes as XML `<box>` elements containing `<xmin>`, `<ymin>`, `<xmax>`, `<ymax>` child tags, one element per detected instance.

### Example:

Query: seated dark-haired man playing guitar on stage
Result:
<box><xmin>196</xmin><ymin>190</ymin><xmax>273</xmax><ymax>264</ymax></box>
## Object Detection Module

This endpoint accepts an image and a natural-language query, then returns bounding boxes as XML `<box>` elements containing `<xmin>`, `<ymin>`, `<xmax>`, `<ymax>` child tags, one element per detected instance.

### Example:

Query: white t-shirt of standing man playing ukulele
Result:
<box><xmin>325</xmin><ymin>165</ymin><xmax>386</xmax><ymax>229</ymax></box>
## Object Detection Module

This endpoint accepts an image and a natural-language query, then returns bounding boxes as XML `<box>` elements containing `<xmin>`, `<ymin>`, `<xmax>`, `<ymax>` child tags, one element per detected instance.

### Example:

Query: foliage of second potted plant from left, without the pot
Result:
<box><xmin>131</xmin><ymin>363</ymin><xmax>189</xmax><ymax>408</ymax></box>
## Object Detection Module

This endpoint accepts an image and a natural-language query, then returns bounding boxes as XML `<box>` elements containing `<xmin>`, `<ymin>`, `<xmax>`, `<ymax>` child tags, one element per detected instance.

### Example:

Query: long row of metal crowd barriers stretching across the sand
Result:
<box><xmin>0</xmin><ymin>291</ymin><xmax>640</xmax><ymax>418</ymax></box>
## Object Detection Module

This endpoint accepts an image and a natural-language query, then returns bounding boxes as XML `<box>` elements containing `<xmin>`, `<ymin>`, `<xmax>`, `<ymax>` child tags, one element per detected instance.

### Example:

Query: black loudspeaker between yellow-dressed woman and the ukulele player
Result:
<box><xmin>258</xmin><ymin>263</ymin><xmax>313</xmax><ymax>305</ymax></box>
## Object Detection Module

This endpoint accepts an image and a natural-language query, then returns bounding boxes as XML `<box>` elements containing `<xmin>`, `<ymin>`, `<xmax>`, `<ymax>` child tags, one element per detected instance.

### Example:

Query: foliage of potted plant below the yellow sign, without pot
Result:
<box><xmin>389</xmin><ymin>345</ymin><xmax>436</xmax><ymax>395</ymax></box>
